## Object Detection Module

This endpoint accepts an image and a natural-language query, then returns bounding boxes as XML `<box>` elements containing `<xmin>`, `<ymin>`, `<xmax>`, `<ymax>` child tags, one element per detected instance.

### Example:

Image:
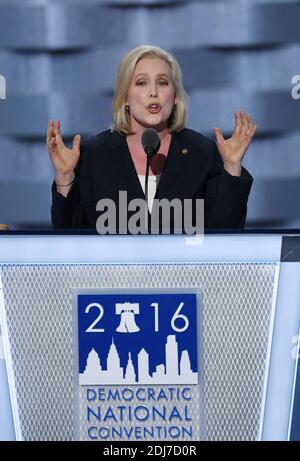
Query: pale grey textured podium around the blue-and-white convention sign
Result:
<box><xmin>0</xmin><ymin>231</ymin><xmax>300</xmax><ymax>440</ymax></box>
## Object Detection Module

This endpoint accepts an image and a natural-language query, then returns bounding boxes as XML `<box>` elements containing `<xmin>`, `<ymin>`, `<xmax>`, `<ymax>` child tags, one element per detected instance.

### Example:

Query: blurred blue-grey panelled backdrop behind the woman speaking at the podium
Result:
<box><xmin>0</xmin><ymin>0</ymin><xmax>300</xmax><ymax>228</ymax></box>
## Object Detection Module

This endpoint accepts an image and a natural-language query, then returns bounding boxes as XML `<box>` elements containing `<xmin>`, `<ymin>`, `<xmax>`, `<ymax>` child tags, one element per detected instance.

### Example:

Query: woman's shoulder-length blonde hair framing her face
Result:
<box><xmin>112</xmin><ymin>45</ymin><xmax>187</xmax><ymax>134</ymax></box>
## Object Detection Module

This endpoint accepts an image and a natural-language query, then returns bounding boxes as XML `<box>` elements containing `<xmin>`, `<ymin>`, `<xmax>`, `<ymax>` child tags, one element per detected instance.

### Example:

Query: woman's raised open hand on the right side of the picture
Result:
<box><xmin>214</xmin><ymin>110</ymin><xmax>257</xmax><ymax>176</ymax></box>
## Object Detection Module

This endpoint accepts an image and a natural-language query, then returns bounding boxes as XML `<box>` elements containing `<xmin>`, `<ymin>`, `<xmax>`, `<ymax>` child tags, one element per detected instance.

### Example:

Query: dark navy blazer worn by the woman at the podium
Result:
<box><xmin>51</xmin><ymin>129</ymin><xmax>252</xmax><ymax>233</ymax></box>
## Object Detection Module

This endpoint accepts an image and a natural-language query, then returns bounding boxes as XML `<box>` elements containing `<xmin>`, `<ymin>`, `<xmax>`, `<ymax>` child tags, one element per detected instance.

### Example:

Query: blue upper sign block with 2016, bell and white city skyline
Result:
<box><xmin>78</xmin><ymin>293</ymin><xmax>198</xmax><ymax>385</ymax></box>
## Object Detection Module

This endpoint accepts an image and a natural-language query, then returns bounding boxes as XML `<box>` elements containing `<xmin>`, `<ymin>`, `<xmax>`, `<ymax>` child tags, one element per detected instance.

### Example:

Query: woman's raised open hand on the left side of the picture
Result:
<box><xmin>46</xmin><ymin>120</ymin><xmax>81</xmax><ymax>182</ymax></box>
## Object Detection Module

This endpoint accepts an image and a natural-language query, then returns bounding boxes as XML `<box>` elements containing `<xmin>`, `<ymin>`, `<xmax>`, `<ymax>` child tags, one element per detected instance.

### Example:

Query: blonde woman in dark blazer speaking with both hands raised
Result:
<box><xmin>47</xmin><ymin>46</ymin><xmax>256</xmax><ymax>233</ymax></box>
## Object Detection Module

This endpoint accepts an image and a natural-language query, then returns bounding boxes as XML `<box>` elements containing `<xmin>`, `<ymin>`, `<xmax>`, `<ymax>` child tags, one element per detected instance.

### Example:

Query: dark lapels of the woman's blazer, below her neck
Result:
<box><xmin>107</xmin><ymin>132</ymin><xmax>188</xmax><ymax>199</ymax></box>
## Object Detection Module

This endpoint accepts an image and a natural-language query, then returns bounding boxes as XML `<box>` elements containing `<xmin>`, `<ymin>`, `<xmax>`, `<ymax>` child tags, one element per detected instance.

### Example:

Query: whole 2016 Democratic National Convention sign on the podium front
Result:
<box><xmin>74</xmin><ymin>289</ymin><xmax>203</xmax><ymax>441</ymax></box>
